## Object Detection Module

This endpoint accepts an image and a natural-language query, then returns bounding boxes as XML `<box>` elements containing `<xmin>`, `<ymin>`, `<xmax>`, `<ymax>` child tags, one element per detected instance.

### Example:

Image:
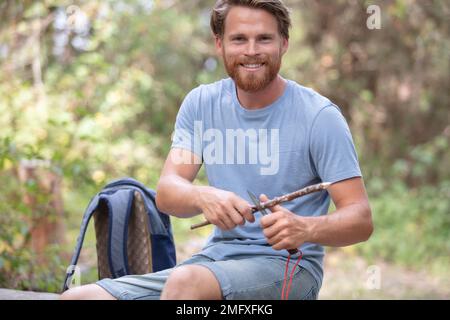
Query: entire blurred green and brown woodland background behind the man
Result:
<box><xmin>0</xmin><ymin>0</ymin><xmax>450</xmax><ymax>298</ymax></box>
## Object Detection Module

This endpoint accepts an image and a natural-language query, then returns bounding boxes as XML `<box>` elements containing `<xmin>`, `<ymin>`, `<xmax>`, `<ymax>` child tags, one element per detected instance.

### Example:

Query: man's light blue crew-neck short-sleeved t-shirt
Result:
<box><xmin>172</xmin><ymin>78</ymin><xmax>361</xmax><ymax>287</ymax></box>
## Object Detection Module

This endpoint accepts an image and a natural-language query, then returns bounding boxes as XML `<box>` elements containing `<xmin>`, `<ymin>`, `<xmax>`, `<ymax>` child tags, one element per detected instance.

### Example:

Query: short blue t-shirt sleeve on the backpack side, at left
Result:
<box><xmin>171</xmin><ymin>89</ymin><xmax>202</xmax><ymax>159</ymax></box>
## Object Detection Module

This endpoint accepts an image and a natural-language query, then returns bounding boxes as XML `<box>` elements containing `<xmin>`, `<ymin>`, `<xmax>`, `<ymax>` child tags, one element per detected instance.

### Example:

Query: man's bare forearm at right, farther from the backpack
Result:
<box><xmin>306</xmin><ymin>203</ymin><xmax>373</xmax><ymax>247</ymax></box>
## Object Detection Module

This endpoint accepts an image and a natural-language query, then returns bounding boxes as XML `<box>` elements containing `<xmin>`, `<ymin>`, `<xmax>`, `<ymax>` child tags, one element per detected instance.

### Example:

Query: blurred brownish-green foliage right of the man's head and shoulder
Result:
<box><xmin>284</xmin><ymin>0</ymin><xmax>450</xmax><ymax>187</ymax></box>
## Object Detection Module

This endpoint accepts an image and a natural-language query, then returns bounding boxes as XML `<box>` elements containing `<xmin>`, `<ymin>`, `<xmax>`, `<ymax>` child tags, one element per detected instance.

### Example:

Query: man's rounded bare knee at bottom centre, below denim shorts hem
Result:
<box><xmin>161</xmin><ymin>265</ymin><xmax>222</xmax><ymax>300</ymax></box>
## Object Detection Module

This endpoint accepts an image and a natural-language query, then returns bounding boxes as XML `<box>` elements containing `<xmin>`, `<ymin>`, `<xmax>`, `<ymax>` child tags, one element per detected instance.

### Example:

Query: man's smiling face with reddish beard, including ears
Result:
<box><xmin>216</xmin><ymin>6</ymin><xmax>288</xmax><ymax>92</ymax></box>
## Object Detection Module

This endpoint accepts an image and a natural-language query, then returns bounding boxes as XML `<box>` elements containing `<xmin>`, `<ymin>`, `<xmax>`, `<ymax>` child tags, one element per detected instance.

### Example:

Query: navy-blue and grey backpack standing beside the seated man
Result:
<box><xmin>63</xmin><ymin>178</ymin><xmax>176</xmax><ymax>291</ymax></box>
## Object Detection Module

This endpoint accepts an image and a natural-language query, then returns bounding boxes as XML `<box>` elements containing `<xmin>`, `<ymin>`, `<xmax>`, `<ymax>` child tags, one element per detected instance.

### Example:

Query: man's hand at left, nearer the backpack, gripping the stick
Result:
<box><xmin>197</xmin><ymin>186</ymin><xmax>255</xmax><ymax>230</ymax></box>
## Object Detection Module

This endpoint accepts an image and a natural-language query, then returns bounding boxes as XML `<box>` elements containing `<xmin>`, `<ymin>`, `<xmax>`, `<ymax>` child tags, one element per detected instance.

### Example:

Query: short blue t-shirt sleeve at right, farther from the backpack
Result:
<box><xmin>309</xmin><ymin>105</ymin><xmax>362</xmax><ymax>183</ymax></box>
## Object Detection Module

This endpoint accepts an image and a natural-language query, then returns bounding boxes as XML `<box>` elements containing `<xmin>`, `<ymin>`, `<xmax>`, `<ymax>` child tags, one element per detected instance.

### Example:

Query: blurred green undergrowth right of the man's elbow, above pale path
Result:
<box><xmin>356</xmin><ymin>181</ymin><xmax>450</xmax><ymax>273</ymax></box>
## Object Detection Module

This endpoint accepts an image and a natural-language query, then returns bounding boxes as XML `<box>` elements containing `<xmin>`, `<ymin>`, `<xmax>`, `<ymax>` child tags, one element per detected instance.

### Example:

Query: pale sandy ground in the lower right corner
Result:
<box><xmin>319</xmin><ymin>250</ymin><xmax>450</xmax><ymax>299</ymax></box>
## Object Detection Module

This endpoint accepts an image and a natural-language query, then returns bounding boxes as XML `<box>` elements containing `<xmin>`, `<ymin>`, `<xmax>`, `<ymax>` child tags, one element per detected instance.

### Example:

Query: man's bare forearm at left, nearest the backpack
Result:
<box><xmin>156</xmin><ymin>175</ymin><xmax>205</xmax><ymax>218</ymax></box>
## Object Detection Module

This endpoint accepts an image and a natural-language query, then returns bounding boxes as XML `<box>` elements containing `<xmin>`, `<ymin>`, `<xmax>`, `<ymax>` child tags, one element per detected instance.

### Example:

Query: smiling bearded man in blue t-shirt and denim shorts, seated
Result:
<box><xmin>63</xmin><ymin>0</ymin><xmax>373</xmax><ymax>300</ymax></box>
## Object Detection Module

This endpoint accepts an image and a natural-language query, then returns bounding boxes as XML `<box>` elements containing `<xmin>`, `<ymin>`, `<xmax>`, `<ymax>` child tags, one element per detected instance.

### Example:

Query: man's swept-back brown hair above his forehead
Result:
<box><xmin>210</xmin><ymin>0</ymin><xmax>291</xmax><ymax>39</ymax></box>
